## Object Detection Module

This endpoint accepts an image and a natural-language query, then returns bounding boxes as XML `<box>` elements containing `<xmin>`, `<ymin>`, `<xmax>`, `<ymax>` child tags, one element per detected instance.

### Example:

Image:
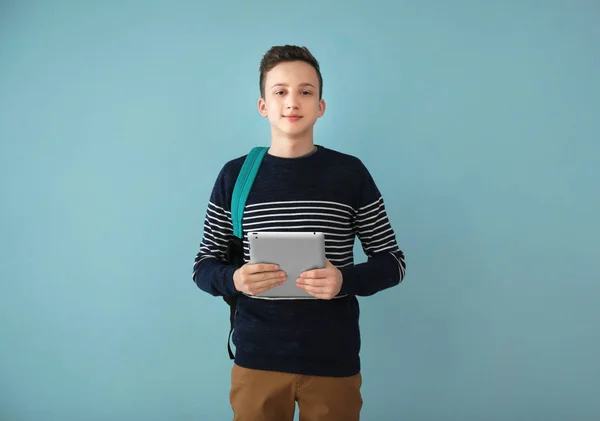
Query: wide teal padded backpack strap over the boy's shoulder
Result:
<box><xmin>231</xmin><ymin>146</ymin><xmax>269</xmax><ymax>238</ymax></box>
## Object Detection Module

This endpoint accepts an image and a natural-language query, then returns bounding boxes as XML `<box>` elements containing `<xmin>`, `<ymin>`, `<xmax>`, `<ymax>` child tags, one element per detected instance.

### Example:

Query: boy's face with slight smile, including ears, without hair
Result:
<box><xmin>258</xmin><ymin>61</ymin><xmax>325</xmax><ymax>137</ymax></box>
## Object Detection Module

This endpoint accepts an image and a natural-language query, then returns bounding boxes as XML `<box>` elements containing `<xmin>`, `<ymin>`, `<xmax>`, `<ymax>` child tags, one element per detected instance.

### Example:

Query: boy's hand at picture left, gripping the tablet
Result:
<box><xmin>233</xmin><ymin>263</ymin><xmax>286</xmax><ymax>295</ymax></box>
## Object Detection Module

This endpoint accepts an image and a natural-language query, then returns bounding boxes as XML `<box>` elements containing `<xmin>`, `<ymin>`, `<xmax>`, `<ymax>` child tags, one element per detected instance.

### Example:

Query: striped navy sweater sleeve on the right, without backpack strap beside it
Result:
<box><xmin>340</xmin><ymin>162</ymin><xmax>406</xmax><ymax>296</ymax></box>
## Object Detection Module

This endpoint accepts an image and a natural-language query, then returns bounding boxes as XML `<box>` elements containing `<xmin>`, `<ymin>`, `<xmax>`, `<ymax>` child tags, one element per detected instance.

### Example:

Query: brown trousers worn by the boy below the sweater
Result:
<box><xmin>229</xmin><ymin>364</ymin><xmax>363</xmax><ymax>421</ymax></box>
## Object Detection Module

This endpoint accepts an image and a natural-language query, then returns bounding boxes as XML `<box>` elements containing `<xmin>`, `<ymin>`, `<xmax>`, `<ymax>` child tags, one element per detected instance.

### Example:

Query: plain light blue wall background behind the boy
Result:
<box><xmin>0</xmin><ymin>0</ymin><xmax>600</xmax><ymax>421</ymax></box>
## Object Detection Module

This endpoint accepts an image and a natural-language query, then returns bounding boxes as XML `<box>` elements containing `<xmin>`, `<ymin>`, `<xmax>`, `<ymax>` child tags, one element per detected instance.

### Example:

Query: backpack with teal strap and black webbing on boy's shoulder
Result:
<box><xmin>223</xmin><ymin>146</ymin><xmax>269</xmax><ymax>360</ymax></box>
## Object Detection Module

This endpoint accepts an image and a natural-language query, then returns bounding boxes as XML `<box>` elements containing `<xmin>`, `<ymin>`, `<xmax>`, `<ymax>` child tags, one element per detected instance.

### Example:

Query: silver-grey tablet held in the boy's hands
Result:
<box><xmin>248</xmin><ymin>231</ymin><xmax>325</xmax><ymax>298</ymax></box>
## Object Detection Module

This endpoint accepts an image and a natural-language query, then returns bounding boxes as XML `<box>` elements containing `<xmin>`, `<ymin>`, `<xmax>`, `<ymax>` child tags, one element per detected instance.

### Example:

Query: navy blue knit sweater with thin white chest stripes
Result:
<box><xmin>193</xmin><ymin>146</ymin><xmax>406</xmax><ymax>377</ymax></box>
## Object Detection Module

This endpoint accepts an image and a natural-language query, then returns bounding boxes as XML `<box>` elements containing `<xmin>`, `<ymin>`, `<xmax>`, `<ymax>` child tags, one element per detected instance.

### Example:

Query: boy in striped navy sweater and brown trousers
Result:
<box><xmin>193</xmin><ymin>45</ymin><xmax>406</xmax><ymax>421</ymax></box>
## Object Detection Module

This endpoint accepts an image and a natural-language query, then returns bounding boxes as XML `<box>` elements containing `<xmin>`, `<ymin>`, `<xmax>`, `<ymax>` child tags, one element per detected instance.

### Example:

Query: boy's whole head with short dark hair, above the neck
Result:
<box><xmin>258</xmin><ymin>45</ymin><xmax>325</xmax><ymax>137</ymax></box>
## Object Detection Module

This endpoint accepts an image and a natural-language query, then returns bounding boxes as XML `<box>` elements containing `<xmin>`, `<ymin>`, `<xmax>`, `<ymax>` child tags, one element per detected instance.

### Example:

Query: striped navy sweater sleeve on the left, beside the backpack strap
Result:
<box><xmin>192</xmin><ymin>163</ymin><xmax>237</xmax><ymax>296</ymax></box>
